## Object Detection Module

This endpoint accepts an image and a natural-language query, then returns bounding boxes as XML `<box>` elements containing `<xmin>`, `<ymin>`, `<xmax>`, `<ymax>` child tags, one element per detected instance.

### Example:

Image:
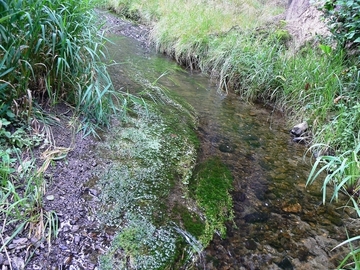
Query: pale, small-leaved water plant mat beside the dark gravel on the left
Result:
<box><xmin>98</xmin><ymin>92</ymin><xmax>201</xmax><ymax>269</ymax></box>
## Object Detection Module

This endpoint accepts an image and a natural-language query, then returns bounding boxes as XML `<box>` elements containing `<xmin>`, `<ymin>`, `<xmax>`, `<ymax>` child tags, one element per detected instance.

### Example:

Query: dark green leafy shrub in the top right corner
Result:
<box><xmin>322</xmin><ymin>0</ymin><xmax>360</xmax><ymax>46</ymax></box>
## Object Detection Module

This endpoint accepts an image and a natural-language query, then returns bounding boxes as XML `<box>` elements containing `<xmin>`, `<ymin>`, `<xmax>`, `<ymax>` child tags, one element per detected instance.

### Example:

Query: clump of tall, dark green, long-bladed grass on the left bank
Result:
<box><xmin>0</xmin><ymin>0</ymin><xmax>121</xmax><ymax>131</ymax></box>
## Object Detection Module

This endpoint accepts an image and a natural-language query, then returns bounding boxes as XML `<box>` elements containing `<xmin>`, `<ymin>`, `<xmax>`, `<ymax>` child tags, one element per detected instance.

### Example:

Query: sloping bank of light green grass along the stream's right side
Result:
<box><xmin>104</xmin><ymin>0</ymin><xmax>359</xmax><ymax>154</ymax></box>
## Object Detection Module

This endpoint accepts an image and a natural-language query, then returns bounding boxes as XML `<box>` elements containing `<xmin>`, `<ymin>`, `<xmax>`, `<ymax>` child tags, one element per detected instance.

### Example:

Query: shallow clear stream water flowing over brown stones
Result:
<box><xmin>105</xmin><ymin>30</ymin><xmax>359</xmax><ymax>269</ymax></box>
